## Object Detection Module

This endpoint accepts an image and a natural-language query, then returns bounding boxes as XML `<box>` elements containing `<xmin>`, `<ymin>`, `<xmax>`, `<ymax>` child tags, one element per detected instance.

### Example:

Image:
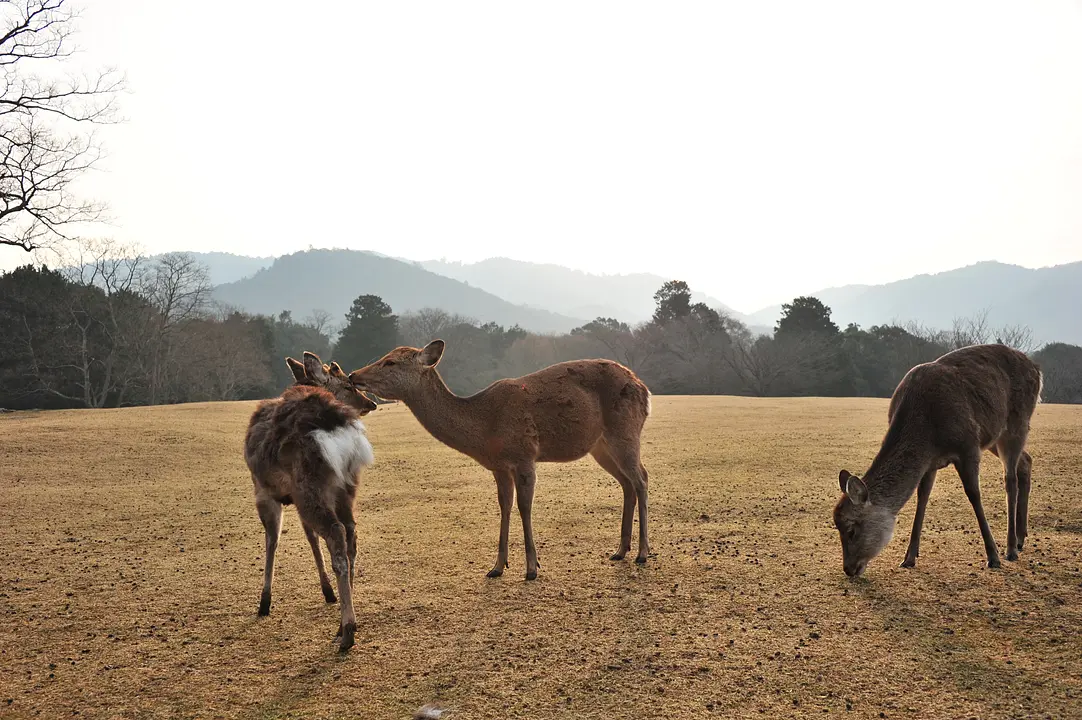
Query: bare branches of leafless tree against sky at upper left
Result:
<box><xmin>0</xmin><ymin>0</ymin><xmax>123</xmax><ymax>251</ymax></box>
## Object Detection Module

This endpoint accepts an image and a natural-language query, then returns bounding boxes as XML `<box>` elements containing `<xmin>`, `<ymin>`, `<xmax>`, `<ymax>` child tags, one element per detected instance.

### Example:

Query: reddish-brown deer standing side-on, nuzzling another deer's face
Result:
<box><xmin>349</xmin><ymin>340</ymin><xmax>650</xmax><ymax>580</ymax></box>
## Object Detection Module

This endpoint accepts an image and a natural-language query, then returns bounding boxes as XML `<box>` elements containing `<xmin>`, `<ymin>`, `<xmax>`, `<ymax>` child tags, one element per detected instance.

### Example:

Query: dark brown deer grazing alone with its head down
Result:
<box><xmin>834</xmin><ymin>344</ymin><xmax>1042</xmax><ymax>577</ymax></box>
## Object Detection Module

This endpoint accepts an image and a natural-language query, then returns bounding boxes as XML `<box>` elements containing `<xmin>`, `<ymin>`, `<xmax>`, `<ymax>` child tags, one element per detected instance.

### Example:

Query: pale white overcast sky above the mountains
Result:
<box><xmin>0</xmin><ymin>0</ymin><xmax>1082</xmax><ymax>312</ymax></box>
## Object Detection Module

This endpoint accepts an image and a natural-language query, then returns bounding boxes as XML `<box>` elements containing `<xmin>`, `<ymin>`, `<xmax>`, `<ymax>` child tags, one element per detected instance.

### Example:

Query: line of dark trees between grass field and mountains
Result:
<box><xmin>0</xmin><ymin>249</ymin><xmax>1082</xmax><ymax>409</ymax></box>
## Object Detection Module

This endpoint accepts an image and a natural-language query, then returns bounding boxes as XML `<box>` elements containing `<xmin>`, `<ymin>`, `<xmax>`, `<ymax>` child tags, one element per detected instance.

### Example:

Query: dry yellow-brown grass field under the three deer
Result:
<box><xmin>0</xmin><ymin>397</ymin><xmax>1082</xmax><ymax>720</ymax></box>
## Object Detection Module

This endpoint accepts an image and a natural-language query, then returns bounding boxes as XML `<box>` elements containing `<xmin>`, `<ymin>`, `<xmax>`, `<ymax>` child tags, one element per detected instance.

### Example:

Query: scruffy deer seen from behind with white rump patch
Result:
<box><xmin>245</xmin><ymin>352</ymin><xmax>375</xmax><ymax>651</ymax></box>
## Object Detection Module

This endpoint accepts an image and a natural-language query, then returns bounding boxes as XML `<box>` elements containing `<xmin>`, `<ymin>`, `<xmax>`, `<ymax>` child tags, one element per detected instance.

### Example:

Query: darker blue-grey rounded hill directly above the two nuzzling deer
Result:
<box><xmin>214</xmin><ymin>250</ymin><xmax>585</xmax><ymax>332</ymax></box>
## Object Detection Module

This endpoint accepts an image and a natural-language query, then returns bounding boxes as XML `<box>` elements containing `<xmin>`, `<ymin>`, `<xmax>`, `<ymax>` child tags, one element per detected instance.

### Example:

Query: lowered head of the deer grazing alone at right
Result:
<box><xmin>834</xmin><ymin>470</ymin><xmax>897</xmax><ymax>577</ymax></box>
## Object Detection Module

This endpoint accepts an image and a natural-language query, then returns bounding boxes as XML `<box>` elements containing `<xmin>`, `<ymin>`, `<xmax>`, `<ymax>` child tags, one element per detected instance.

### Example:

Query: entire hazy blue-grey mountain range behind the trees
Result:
<box><xmin>195</xmin><ymin>250</ymin><xmax>1082</xmax><ymax>344</ymax></box>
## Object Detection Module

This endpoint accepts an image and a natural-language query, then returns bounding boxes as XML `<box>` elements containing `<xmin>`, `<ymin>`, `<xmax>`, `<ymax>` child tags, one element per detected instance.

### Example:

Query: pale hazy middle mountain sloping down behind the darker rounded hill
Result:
<box><xmin>419</xmin><ymin>258</ymin><xmax>743</xmax><ymax>325</ymax></box>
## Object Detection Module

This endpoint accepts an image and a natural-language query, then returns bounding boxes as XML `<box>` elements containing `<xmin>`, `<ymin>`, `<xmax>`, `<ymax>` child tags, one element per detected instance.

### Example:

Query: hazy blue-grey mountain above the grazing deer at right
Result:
<box><xmin>749</xmin><ymin>262</ymin><xmax>1082</xmax><ymax>344</ymax></box>
